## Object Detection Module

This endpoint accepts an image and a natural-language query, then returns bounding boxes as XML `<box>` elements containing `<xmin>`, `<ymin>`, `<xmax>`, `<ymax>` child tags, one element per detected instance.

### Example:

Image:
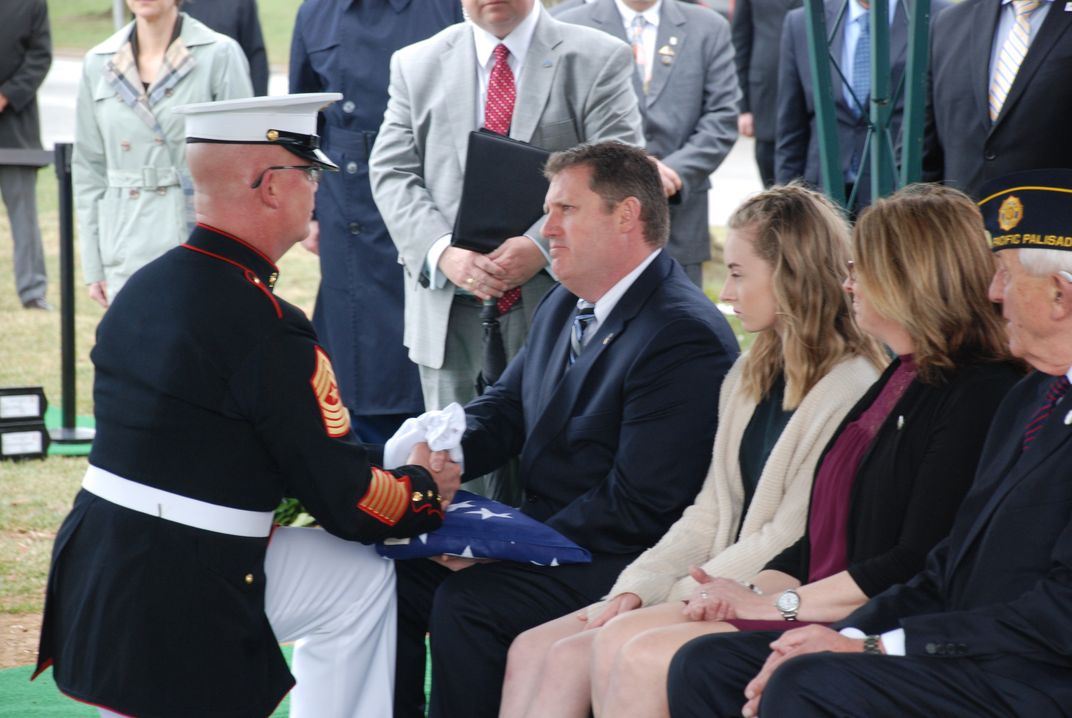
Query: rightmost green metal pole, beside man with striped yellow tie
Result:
<box><xmin>900</xmin><ymin>0</ymin><xmax>930</xmax><ymax>186</ymax></box>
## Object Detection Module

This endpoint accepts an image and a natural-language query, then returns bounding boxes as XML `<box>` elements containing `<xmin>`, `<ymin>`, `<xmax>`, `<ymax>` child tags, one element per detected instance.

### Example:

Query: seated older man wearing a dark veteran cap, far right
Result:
<box><xmin>668</xmin><ymin>169</ymin><xmax>1072</xmax><ymax>717</ymax></box>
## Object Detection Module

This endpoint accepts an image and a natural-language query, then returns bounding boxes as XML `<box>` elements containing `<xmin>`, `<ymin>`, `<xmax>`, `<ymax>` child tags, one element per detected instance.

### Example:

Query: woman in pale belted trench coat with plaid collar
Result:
<box><xmin>72</xmin><ymin>0</ymin><xmax>253</xmax><ymax>306</ymax></box>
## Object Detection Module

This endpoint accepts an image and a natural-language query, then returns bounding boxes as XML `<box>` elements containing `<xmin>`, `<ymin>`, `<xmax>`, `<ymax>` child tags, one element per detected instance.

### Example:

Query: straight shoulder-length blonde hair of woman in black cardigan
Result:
<box><xmin>852</xmin><ymin>184</ymin><xmax>1010</xmax><ymax>384</ymax></box>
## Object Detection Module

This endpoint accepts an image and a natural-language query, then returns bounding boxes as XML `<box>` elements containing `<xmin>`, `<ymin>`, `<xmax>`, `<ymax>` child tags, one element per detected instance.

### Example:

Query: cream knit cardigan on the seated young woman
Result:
<box><xmin>589</xmin><ymin>355</ymin><xmax>879</xmax><ymax>617</ymax></box>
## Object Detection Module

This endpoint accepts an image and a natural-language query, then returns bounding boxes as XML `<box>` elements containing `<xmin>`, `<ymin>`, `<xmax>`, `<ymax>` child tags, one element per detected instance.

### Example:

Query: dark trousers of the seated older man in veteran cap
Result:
<box><xmin>667</xmin><ymin>632</ymin><xmax>1063</xmax><ymax>718</ymax></box>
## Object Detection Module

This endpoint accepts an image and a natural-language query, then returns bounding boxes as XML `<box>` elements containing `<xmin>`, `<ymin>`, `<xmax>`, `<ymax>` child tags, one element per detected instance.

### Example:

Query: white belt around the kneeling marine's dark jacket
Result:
<box><xmin>81</xmin><ymin>465</ymin><xmax>273</xmax><ymax>538</ymax></box>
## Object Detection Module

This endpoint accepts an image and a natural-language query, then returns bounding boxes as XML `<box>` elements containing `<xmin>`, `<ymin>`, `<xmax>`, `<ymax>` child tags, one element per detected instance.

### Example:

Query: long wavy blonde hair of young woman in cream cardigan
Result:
<box><xmin>728</xmin><ymin>183</ymin><xmax>887</xmax><ymax>409</ymax></box>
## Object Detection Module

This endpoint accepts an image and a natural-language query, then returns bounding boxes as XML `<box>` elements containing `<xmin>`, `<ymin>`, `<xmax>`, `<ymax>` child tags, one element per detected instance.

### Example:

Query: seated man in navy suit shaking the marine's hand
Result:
<box><xmin>394</xmin><ymin>143</ymin><xmax>738</xmax><ymax>718</ymax></box>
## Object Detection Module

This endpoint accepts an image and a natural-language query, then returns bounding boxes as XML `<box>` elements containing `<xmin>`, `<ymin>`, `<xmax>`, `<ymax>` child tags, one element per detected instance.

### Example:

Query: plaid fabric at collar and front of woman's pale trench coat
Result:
<box><xmin>103</xmin><ymin>22</ymin><xmax>197</xmax><ymax>231</ymax></box>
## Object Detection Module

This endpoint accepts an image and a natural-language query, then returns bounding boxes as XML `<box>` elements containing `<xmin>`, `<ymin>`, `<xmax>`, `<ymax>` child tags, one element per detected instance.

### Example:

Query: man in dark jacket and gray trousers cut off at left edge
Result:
<box><xmin>0</xmin><ymin>0</ymin><xmax>53</xmax><ymax>310</ymax></box>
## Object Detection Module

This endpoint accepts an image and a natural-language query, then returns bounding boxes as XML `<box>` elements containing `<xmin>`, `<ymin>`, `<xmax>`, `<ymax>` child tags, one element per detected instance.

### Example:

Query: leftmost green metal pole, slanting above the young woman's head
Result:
<box><xmin>804</xmin><ymin>0</ymin><xmax>851</xmax><ymax>207</ymax></box>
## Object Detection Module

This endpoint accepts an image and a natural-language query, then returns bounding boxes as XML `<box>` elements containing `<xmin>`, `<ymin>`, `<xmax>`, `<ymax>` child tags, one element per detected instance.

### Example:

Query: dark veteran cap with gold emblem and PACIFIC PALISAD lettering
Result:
<box><xmin>979</xmin><ymin>169</ymin><xmax>1072</xmax><ymax>252</ymax></box>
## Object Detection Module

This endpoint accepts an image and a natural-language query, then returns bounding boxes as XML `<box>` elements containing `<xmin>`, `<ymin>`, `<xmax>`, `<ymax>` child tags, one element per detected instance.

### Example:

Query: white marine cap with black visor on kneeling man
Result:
<box><xmin>175</xmin><ymin>92</ymin><xmax>342</xmax><ymax>169</ymax></box>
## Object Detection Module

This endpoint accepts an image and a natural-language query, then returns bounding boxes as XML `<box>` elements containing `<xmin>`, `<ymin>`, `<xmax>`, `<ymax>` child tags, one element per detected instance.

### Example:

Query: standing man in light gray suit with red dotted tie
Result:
<box><xmin>369</xmin><ymin>0</ymin><xmax>641</xmax><ymax>424</ymax></box>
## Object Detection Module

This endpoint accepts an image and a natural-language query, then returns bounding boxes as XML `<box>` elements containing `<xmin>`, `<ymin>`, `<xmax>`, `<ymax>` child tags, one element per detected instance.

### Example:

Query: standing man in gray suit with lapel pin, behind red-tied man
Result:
<box><xmin>556</xmin><ymin>0</ymin><xmax>741</xmax><ymax>288</ymax></box>
